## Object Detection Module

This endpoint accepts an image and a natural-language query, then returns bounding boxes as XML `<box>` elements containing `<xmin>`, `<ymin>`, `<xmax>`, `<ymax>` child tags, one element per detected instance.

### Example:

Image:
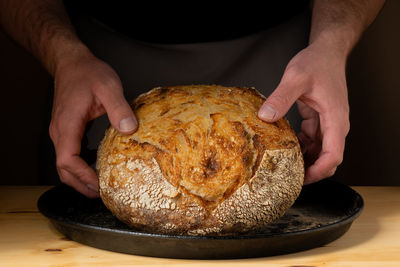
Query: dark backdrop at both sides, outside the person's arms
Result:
<box><xmin>0</xmin><ymin>0</ymin><xmax>400</xmax><ymax>185</ymax></box>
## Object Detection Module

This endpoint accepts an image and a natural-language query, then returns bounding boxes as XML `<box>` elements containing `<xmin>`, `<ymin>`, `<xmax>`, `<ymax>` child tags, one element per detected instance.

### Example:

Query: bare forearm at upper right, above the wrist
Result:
<box><xmin>309</xmin><ymin>0</ymin><xmax>385</xmax><ymax>58</ymax></box>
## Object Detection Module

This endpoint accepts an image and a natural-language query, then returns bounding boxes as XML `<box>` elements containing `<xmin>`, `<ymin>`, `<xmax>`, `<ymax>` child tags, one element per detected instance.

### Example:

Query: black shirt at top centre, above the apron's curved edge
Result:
<box><xmin>64</xmin><ymin>0</ymin><xmax>309</xmax><ymax>43</ymax></box>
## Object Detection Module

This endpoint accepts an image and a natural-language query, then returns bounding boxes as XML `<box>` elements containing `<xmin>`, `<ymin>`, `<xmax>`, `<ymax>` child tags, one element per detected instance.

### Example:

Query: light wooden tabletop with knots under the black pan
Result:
<box><xmin>0</xmin><ymin>186</ymin><xmax>400</xmax><ymax>267</ymax></box>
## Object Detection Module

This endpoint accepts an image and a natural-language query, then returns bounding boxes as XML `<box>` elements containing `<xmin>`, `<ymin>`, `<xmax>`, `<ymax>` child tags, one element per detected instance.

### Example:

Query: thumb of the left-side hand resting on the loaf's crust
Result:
<box><xmin>96</xmin><ymin>79</ymin><xmax>138</xmax><ymax>134</ymax></box>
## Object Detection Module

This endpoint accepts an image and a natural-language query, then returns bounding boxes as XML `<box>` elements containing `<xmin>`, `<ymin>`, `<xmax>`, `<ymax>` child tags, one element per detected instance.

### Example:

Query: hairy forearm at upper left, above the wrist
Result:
<box><xmin>0</xmin><ymin>0</ymin><xmax>88</xmax><ymax>76</ymax></box>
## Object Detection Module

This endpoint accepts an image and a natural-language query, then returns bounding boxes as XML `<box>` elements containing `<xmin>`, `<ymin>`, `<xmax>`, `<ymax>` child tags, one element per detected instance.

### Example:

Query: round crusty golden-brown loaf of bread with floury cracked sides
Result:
<box><xmin>97</xmin><ymin>85</ymin><xmax>304</xmax><ymax>235</ymax></box>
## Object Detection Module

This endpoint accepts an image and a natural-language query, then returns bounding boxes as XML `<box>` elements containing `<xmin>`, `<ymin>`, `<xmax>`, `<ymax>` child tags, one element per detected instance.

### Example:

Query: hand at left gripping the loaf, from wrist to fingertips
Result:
<box><xmin>49</xmin><ymin>51</ymin><xmax>137</xmax><ymax>198</ymax></box>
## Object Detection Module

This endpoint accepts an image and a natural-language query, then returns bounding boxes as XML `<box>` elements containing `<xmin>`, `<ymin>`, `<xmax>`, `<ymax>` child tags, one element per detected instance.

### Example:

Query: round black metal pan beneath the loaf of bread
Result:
<box><xmin>38</xmin><ymin>180</ymin><xmax>363</xmax><ymax>259</ymax></box>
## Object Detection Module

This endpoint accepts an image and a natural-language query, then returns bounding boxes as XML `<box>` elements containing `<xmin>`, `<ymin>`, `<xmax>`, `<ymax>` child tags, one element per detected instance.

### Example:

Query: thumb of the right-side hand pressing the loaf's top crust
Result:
<box><xmin>258</xmin><ymin>83</ymin><xmax>301</xmax><ymax>122</ymax></box>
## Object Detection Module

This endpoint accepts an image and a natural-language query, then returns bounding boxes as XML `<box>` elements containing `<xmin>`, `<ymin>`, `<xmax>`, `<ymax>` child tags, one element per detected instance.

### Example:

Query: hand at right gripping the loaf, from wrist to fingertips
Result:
<box><xmin>258</xmin><ymin>42</ymin><xmax>350</xmax><ymax>184</ymax></box>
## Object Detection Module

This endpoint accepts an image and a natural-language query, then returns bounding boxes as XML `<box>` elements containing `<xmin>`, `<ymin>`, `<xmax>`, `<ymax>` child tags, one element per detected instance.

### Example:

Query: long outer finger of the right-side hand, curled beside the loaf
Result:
<box><xmin>306</xmin><ymin>112</ymin><xmax>348</xmax><ymax>183</ymax></box>
